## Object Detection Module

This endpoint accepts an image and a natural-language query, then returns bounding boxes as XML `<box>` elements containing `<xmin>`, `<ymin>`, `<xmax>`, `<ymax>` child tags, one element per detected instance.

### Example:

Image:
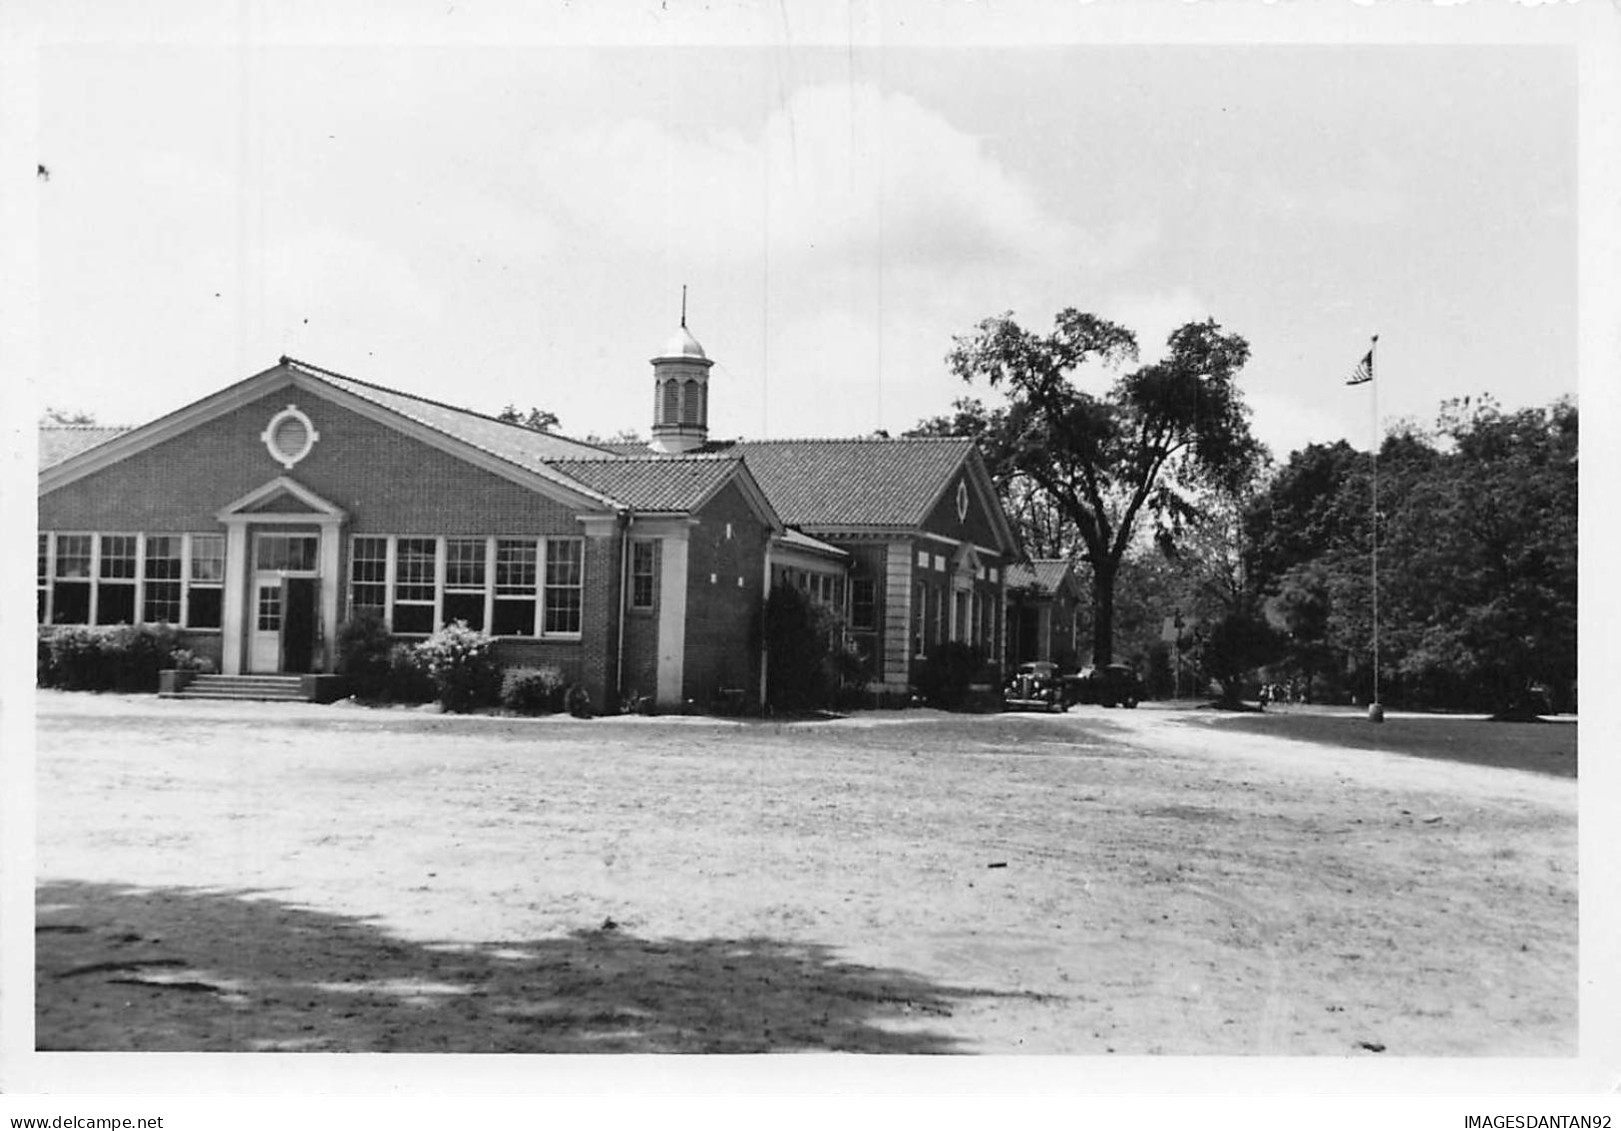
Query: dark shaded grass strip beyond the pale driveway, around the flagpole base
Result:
<box><xmin>1217</xmin><ymin>711</ymin><xmax>1576</xmax><ymax>778</ymax></box>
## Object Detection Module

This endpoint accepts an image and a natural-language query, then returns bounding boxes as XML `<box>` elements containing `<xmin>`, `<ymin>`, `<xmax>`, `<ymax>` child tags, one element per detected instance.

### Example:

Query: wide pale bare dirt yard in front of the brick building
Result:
<box><xmin>36</xmin><ymin>692</ymin><xmax>1577</xmax><ymax>1058</ymax></box>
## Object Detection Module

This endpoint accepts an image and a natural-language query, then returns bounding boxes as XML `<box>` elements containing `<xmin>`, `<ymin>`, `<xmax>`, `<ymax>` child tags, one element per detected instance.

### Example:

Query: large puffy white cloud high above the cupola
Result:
<box><xmin>535</xmin><ymin>84</ymin><xmax>1102</xmax><ymax>271</ymax></box>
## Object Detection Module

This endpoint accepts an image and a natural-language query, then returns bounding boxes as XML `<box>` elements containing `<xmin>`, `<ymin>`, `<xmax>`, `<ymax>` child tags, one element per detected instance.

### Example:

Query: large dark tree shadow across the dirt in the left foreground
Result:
<box><xmin>36</xmin><ymin>881</ymin><xmax>1024</xmax><ymax>1053</ymax></box>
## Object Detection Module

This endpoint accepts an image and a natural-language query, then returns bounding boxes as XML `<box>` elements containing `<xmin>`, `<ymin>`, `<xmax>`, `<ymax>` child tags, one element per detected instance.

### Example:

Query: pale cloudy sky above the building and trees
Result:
<box><xmin>12</xmin><ymin>5</ymin><xmax>1577</xmax><ymax>455</ymax></box>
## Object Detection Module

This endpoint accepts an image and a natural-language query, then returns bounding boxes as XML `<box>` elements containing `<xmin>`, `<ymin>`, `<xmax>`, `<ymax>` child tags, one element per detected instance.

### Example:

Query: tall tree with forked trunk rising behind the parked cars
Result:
<box><xmin>947</xmin><ymin>309</ymin><xmax>1261</xmax><ymax>664</ymax></box>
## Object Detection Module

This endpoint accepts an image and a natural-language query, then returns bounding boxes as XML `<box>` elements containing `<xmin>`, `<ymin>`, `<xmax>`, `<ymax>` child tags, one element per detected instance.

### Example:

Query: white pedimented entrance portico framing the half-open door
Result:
<box><xmin>216</xmin><ymin>475</ymin><xmax>349</xmax><ymax>676</ymax></box>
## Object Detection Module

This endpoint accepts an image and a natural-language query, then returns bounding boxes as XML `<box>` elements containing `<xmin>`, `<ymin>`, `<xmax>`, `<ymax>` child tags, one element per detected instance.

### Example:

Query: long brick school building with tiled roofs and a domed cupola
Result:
<box><xmin>37</xmin><ymin>320</ymin><xmax>1018</xmax><ymax>708</ymax></box>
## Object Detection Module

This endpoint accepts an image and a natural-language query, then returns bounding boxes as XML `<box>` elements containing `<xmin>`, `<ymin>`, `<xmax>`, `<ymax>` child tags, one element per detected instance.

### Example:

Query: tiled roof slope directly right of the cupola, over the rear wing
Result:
<box><xmin>710</xmin><ymin>437</ymin><xmax>974</xmax><ymax>528</ymax></box>
